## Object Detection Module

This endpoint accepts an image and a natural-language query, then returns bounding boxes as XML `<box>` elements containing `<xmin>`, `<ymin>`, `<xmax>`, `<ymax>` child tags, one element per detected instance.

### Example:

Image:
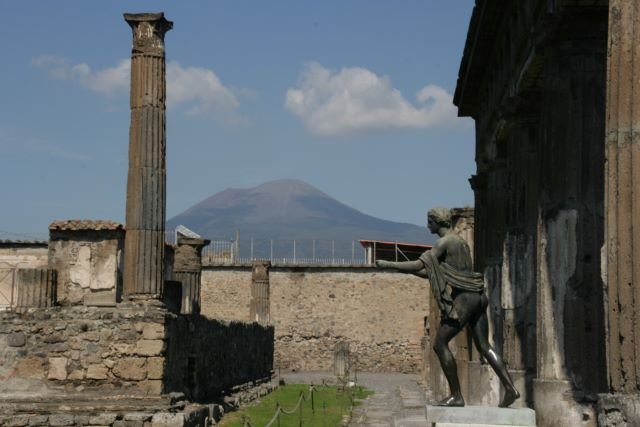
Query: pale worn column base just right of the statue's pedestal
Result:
<box><xmin>533</xmin><ymin>378</ymin><xmax>597</xmax><ymax>427</ymax></box>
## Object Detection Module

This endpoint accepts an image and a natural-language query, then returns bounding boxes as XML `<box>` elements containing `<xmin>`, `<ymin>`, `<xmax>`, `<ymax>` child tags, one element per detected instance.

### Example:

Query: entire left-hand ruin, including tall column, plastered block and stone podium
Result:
<box><xmin>0</xmin><ymin>13</ymin><xmax>274</xmax><ymax>427</ymax></box>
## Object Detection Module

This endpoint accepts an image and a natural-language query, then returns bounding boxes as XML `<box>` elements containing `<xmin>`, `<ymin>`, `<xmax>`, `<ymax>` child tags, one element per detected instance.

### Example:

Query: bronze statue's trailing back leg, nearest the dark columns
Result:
<box><xmin>469</xmin><ymin>295</ymin><xmax>520</xmax><ymax>408</ymax></box>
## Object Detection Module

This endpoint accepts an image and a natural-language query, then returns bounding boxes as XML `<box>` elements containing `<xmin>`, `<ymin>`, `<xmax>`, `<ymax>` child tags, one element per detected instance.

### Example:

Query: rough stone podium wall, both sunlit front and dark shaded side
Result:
<box><xmin>0</xmin><ymin>305</ymin><xmax>273</xmax><ymax>401</ymax></box>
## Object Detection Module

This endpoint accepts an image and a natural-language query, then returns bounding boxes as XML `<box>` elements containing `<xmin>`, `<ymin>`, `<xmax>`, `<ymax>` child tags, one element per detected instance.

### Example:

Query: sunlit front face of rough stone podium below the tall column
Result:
<box><xmin>0</xmin><ymin>306</ymin><xmax>166</xmax><ymax>397</ymax></box>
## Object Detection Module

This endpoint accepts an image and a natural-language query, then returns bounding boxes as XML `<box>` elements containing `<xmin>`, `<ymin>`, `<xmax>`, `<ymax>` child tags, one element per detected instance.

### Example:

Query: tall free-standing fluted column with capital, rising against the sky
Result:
<box><xmin>124</xmin><ymin>13</ymin><xmax>173</xmax><ymax>298</ymax></box>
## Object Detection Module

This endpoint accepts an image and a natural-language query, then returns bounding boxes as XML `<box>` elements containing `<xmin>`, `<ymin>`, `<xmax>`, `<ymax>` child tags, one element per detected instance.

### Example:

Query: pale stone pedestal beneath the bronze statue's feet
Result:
<box><xmin>425</xmin><ymin>405</ymin><xmax>536</xmax><ymax>427</ymax></box>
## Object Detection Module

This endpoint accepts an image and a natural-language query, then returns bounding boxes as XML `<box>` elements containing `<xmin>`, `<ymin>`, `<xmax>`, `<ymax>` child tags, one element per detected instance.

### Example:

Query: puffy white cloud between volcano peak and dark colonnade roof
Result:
<box><xmin>285</xmin><ymin>62</ymin><xmax>457</xmax><ymax>136</ymax></box>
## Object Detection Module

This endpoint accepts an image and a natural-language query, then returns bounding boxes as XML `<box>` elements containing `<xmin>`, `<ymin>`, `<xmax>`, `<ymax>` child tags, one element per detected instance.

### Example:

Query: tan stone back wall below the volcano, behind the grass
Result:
<box><xmin>202</xmin><ymin>267</ymin><xmax>429</xmax><ymax>373</ymax></box>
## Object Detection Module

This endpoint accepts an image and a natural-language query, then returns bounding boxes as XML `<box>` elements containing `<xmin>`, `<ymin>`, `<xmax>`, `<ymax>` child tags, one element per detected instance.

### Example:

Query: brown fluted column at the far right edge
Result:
<box><xmin>599</xmin><ymin>0</ymin><xmax>640</xmax><ymax>425</ymax></box>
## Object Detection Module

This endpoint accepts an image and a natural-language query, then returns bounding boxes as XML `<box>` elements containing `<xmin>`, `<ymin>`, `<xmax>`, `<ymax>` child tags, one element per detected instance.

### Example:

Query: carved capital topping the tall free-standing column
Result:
<box><xmin>124</xmin><ymin>12</ymin><xmax>173</xmax><ymax>55</ymax></box>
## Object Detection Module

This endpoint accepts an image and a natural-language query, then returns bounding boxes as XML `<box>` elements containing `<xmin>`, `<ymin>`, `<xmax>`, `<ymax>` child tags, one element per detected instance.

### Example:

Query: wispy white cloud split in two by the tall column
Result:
<box><xmin>31</xmin><ymin>56</ymin><xmax>240</xmax><ymax>118</ymax></box>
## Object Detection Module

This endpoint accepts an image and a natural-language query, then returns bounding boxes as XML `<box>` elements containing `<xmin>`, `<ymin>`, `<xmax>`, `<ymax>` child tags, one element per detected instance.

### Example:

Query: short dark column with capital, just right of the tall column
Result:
<box><xmin>173</xmin><ymin>237</ymin><xmax>209</xmax><ymax>314</ymax></box>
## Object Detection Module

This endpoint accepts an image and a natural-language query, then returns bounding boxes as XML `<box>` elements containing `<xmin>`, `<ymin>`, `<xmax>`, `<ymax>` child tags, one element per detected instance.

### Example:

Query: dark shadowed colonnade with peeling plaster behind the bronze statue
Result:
<box><xmin>455</xmin><ymin>0</ymin><xmax>607</xmax><ymax>426</ymax></box>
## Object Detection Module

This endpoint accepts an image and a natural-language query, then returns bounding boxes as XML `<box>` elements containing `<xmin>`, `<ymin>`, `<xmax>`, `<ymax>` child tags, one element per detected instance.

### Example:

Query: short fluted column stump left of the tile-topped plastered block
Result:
<box><xmin>16</xmin><ymin>268</ymin><xmax>56</xmax><ymax>311</ymax></box>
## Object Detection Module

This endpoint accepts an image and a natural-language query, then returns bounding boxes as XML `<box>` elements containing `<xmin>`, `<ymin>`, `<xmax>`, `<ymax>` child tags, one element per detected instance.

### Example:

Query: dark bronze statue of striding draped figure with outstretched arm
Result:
<box><xmin>376</xmin><ymin>208</ymin><xmax>520</xmax><ymax>408</ymax></box>
